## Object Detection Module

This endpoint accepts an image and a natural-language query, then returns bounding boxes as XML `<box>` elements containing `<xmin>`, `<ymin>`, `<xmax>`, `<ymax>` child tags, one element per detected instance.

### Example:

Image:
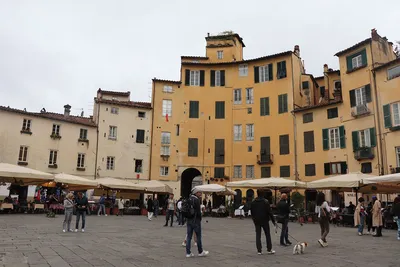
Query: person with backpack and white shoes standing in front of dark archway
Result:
<box><xmin>186</xmin><ymin>188</ymin><xmax>209</xmax><ymax>258</ymax></box>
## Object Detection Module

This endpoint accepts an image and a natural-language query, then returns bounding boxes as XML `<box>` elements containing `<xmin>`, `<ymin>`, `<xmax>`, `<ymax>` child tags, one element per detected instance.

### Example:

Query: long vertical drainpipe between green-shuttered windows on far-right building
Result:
<box><xmin>369</xmin><ymin>41</ymin><xmax>386</xmax><ymax>175</ymax></box>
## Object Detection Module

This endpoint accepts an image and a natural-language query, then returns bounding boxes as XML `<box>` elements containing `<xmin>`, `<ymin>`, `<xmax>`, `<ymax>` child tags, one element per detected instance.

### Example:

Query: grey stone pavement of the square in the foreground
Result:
<box><xmin>0</xmin><ymin>214</ymin><xmax>400</xmax><ymax>267</ymax></box>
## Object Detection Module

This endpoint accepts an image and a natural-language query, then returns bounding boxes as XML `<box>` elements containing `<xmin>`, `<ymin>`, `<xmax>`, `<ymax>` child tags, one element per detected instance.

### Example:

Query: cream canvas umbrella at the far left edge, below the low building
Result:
<box><xmin>0</xmin><ymin>163</ymin><xmax>54</xmax><ymax>186</ymax></box>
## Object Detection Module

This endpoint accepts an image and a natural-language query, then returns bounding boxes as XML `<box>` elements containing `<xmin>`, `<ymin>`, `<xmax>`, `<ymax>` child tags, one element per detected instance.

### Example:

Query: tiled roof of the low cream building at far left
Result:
<box><xmin>0</xmin><ymin>106</ymin><xmax>96</xmax><ymax>127</ymax></box>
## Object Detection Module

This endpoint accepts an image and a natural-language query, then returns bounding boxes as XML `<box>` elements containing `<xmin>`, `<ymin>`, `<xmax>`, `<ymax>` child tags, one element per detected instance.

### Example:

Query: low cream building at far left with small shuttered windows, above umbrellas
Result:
<box><xmin>0</xmin><ymin>105</ymin><xmax>96</xmax><ymax>179</ymax></box>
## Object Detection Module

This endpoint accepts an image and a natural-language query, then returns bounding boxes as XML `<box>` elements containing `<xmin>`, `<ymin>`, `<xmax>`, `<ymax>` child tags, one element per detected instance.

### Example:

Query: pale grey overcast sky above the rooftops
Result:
<box><xmin>0</xmin><ymin>0</ymin><xmax>400</xmax><ymax>115</ymax></box>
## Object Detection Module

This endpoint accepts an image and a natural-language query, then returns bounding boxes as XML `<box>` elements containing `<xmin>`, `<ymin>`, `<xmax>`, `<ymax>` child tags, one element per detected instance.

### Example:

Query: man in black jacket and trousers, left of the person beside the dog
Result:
<box><xmin>251</xmin><ymin>190</ymin><xmax>275</xmax><ymax>255</ymax></box>
